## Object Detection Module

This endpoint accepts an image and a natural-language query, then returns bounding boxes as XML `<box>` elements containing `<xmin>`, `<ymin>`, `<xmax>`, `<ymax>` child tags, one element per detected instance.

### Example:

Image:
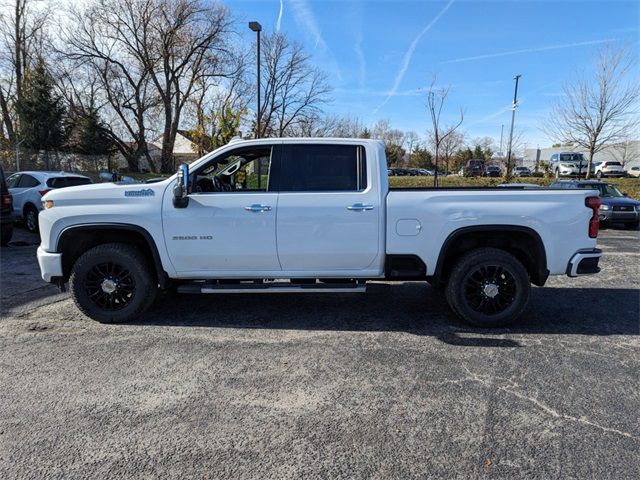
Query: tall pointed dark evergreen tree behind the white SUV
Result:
<box><xmin>16</xmin><ymin>58</ymin><xmax>65</xmax><ymax>151</ymax></box>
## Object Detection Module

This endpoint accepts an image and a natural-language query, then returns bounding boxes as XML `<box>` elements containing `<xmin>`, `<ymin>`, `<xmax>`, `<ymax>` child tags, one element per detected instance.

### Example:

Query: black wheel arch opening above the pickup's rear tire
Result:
<box><xmin>433</xmin><ymin>225</ymin><xmax>549</xmax><ymax>286</ymax></box>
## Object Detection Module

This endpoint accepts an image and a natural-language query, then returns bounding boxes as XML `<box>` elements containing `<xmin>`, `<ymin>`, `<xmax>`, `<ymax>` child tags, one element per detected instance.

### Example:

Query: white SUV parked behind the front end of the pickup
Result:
<box><xmin>7</xmin><ymin>172</ymin><xmax>92</xmax><ymax>233</ymax></box>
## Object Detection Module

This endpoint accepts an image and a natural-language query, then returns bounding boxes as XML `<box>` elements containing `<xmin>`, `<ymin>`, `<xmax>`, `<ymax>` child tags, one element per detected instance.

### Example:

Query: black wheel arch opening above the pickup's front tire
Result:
<box><xmin>54</xmin><ymin>223</ymin><xmax>170</xmax><ymax>288</ymax></box>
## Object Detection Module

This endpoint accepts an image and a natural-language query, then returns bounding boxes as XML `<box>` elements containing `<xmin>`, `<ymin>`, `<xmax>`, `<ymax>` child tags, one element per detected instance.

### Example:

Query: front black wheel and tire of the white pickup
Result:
<box><xmin>69</xmin><ymin>243</ymin><xmax>158</xmax><ymax>323</ymax></box>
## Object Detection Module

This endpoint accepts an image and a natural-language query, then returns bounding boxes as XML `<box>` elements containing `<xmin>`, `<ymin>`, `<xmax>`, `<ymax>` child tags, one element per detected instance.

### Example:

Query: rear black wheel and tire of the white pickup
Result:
<box><xmin>446</xmin><ymin>248</ymin><xmax>531</xmax><ymax>328</ymax></box>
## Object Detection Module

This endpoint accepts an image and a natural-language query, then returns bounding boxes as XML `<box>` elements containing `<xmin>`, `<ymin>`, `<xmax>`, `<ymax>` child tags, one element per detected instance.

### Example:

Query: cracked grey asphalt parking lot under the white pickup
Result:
<box><xmin>0</xmin><ymin>229</ymin><xmax>640</xmax><ymax>479</ymax></box>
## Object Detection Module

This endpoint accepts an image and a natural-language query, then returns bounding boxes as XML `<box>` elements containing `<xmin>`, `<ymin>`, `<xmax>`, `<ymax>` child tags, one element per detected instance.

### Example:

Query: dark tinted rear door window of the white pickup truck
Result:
<box><xmin>279</xmin><ymin>144</ymin><xmax>367</xmax><ymax>192</ymax></box>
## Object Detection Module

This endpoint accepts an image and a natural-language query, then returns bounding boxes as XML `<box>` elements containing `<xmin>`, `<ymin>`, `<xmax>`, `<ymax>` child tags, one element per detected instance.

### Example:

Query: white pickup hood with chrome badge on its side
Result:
<box><xmin>42</xmin><ymin>179</ymin><xmax>171</xmax><ymax>206</ymax></box>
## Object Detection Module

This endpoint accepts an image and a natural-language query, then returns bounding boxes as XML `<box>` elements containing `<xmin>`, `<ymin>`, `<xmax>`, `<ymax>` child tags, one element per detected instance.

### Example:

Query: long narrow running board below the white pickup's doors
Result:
<box><xmin>178</xmin><ymin>282</ymin><xmax>367</xmax><ymax>294</ymax></box>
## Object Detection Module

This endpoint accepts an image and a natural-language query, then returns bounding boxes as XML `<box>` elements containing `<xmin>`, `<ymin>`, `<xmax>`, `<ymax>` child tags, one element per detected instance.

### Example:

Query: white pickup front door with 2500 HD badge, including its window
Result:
<box><xmin>162</xmin><ymin>145</ymin><xmax>280</xmax><ymax>278</ymax></box>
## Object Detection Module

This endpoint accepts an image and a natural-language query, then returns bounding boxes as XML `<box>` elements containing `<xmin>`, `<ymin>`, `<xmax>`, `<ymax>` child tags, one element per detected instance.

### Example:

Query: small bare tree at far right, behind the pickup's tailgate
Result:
<box><xmin>544</xmin><ymin>45</ymin><xmax>640</xmax><ymax>178</ymax></box>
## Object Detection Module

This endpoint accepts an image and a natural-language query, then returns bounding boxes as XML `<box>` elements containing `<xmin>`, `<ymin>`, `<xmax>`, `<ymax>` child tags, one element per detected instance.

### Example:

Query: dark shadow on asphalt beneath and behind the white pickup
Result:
<box><xmin>136</xmin><ymin>282</ymin><xmax>640</xmax><ymax>347</ymax></box>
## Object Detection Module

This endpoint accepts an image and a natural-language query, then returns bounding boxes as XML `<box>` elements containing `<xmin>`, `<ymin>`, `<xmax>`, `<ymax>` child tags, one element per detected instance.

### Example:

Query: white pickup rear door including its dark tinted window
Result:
<box><xmin>276</xmin><ymin>143</ymin><xmax>381</xmax><ymax>273</ymax></box>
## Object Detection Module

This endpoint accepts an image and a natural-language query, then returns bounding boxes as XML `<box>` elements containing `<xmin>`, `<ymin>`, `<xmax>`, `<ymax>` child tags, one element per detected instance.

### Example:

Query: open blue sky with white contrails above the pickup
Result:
<box><xmin>224</xmin><ymin>0</ymin><xmax>640</xmax><ymax>147</ymax></box>
